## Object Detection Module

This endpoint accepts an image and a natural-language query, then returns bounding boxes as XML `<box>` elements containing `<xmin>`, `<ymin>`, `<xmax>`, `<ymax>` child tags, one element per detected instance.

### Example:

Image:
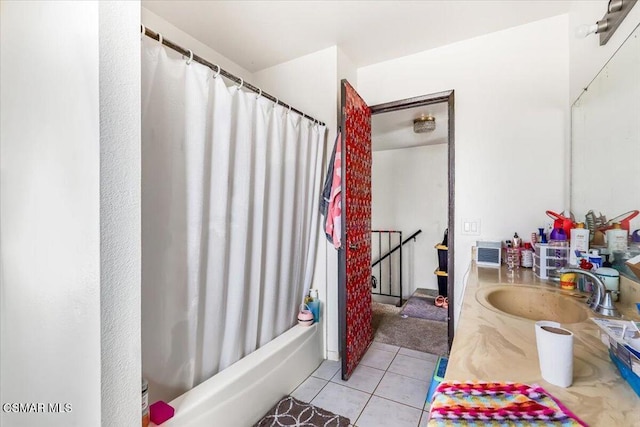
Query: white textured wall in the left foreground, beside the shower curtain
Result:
<box><xmin>0</xmin><ymin>1</ymin><xmax>141</xmax><ymax>427</ymax></box>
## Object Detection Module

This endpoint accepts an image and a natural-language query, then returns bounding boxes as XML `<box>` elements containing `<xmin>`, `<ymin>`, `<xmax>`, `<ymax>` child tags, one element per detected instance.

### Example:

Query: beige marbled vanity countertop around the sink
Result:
<box><xmin>445</xmin><ymin>263</ymin><xmax>640</xmax><ymax>427</ymax></box>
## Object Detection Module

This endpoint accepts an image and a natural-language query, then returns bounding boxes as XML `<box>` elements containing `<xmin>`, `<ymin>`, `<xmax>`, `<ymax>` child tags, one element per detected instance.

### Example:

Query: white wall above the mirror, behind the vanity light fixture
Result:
<box><xmin>568</xmin><ymin>0</ymin><xmax>640</xmax><ymax>103</ymax></box>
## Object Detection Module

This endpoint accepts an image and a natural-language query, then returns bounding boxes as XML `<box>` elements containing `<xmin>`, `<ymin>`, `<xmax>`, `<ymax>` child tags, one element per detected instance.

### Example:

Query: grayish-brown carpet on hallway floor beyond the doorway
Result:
<box><xmin>371</xmin><ymin>302</ymin><xmax>449</xmax><ymax>356</ymax></box>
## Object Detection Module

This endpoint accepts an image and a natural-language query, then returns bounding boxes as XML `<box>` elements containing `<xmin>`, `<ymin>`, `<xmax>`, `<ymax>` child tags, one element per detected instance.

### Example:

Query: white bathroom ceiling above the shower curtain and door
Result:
<box><xmin>142</xmin><ymin>0</ymin><xmax>569</xmax><ymax>72</ymax></box>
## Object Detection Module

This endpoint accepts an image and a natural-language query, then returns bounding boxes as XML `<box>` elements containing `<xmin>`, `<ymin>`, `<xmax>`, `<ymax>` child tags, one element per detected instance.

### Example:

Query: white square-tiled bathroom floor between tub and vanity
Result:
<box><xmin>291</xmin><ymin>341</ymin><xmax>438</xmax><ymax>427</ymax></box>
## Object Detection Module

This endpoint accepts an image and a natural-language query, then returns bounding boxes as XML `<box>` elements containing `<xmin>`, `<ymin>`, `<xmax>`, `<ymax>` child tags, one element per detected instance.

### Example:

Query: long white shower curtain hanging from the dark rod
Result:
<box><xmin>142</xmin><ymin>38</ymin><xmax>326</xmax><ymax>401</ymax></box>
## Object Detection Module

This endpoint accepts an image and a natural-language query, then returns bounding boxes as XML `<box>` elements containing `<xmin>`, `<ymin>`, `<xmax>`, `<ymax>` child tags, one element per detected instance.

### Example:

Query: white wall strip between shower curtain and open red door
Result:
<box><xmin>254</xmin><ymin>46</ymin><xmax>339</xmax><ymax>360</ymax></box>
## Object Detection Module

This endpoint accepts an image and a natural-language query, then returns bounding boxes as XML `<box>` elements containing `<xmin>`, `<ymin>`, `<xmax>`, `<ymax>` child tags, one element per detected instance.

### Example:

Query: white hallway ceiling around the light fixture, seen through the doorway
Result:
<box><xmin>371</xmin><ymin>102</ymin><xmax>448</xmax><ymax>151</ymax></box>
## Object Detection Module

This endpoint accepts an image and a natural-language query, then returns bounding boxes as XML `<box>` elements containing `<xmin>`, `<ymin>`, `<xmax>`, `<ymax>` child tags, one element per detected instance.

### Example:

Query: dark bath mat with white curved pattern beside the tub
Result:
<box><xmin>254</xmin><ymin>396</ymin><xmax>350</xmax><ymax>427</ymax></box>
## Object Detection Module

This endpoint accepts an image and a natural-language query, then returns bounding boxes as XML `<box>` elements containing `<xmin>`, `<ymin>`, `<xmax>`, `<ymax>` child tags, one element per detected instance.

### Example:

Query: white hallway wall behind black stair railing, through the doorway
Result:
<box><xmin>371</xmin><ymin>143</ymin><xmax>448</xmax><ymax>298</ymax></box>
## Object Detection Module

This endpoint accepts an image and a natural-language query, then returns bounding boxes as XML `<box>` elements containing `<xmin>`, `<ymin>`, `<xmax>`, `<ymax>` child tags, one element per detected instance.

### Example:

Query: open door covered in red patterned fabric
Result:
<box><xmin>343</xmin><ymin>83</ymin><xmax>373</xmax><ymax>377</ymax></box>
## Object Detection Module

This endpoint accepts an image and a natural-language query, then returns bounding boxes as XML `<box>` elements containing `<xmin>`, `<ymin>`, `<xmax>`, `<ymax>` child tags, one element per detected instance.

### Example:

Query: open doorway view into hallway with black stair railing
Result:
<box><xmin>371</xmin><ymin>96</ymin><xmax>449</xmax><ymax>356</ymax></box>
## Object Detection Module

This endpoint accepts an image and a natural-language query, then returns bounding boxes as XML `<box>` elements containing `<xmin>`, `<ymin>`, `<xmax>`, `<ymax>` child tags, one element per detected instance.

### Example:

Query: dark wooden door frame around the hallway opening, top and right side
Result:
<box><xmin>369</xmin><ymin>89</ymin><xmax>456</xmax><ymax>350</ymax></box>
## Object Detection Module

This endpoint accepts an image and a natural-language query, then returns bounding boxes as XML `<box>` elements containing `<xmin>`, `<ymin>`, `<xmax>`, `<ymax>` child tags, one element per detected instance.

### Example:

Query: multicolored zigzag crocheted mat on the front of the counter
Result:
<box><xmin>428</xmin><ymin>381</ymin><xmax>586</xmax><ymax>427</ymax></box>
